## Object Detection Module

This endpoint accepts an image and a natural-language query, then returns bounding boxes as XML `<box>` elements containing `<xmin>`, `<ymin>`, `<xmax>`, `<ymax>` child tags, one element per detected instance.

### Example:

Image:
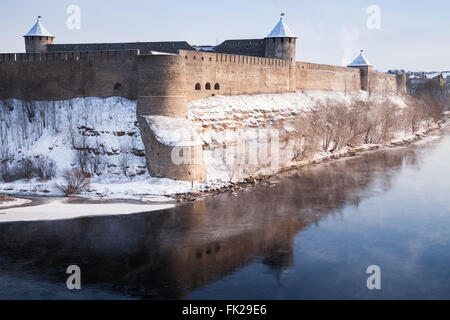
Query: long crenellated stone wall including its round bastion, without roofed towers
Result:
<box><xmin>0</xmin><ymin>49</ymin><xmax>402</xmax><ymax>181</ymax></box>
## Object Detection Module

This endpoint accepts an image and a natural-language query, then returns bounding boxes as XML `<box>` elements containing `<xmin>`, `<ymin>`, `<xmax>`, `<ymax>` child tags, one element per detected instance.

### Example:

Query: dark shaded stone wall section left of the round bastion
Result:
<box><xmin>0</xmin><ymin>50</ymin><xmax>139</xmax><ymax>100</ymax></box>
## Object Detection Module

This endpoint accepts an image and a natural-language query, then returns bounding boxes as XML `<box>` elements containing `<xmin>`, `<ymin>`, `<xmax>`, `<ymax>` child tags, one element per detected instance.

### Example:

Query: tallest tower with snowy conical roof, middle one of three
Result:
<box><xmin>264</xmin><ymin>13</ymin><xmax>297</xmax><ymax>63</ymax></box>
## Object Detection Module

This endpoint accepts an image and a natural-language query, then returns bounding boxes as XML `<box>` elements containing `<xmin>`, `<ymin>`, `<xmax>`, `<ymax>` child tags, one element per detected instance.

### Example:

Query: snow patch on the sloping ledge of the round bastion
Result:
<box><xmin>143</xmin><ymin>116</ymin><xmax>203</xmax><ymax>147</ymax></box>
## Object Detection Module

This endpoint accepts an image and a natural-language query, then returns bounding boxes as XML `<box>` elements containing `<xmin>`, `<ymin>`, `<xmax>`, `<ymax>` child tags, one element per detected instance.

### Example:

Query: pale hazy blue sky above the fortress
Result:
<box><xmin>0</xmin><ymin>0</ymin><xmax>450</xmax><ymax>71</ymax></box>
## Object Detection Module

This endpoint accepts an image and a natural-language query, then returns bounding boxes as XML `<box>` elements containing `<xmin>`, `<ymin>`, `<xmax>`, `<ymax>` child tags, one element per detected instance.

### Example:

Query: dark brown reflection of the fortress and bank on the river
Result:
<box><xmin>0</xmin><ymin>135</ymin><xmax>442</xmax><ymax>299</ymax></box>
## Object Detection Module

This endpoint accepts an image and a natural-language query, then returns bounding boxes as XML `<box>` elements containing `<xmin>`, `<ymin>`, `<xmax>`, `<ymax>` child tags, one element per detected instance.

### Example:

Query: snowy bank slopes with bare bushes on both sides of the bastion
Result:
<box><xmin>0</xmin><ymin>91</ymin><xmax>446</xmax><ymax>202</ymax></box>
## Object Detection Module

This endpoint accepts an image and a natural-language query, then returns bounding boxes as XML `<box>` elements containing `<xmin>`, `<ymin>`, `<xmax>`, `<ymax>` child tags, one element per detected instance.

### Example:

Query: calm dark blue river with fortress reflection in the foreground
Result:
<box><xmin>0</xmin><ymin>129</ymin><xmax>450</xmax><ymax>299</ymax></box>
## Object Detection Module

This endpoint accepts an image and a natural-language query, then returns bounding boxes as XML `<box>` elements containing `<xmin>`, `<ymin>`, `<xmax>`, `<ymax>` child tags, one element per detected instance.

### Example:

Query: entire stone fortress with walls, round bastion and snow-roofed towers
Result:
<box><xmin>0</xmin><ymin>17</ymin><xmax>406</xmax><ymax>182</ymax></box>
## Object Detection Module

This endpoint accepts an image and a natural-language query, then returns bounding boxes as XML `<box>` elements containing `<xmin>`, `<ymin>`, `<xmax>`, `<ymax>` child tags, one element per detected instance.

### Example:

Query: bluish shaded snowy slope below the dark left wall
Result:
<box><xmin>0</xmin><ymin>97</ymin><xmax>195</xmax><ymax>200</ymax></box>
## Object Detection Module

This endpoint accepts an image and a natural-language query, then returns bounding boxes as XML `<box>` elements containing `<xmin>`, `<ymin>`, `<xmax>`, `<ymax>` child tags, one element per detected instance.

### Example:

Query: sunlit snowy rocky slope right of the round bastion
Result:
<box><xmin>188</xmin><ymin>91</ymin><xmax>412</xmax><ymax>183</ymax></box>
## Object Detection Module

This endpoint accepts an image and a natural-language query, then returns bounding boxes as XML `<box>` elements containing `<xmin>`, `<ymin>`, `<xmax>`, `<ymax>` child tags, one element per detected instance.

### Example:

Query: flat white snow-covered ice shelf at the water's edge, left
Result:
<box><xmin>0</xmin><ymin>199</ymin><xmax>175</xmax><ymax>223</ymax></box>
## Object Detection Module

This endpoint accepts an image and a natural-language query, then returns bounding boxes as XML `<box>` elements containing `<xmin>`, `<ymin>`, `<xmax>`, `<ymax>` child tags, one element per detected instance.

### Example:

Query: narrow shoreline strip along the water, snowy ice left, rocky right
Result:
<box><xmin>0</xmin><ymin>120</ymin><xmax>442</xmax><ymax>223</ymax></box>
